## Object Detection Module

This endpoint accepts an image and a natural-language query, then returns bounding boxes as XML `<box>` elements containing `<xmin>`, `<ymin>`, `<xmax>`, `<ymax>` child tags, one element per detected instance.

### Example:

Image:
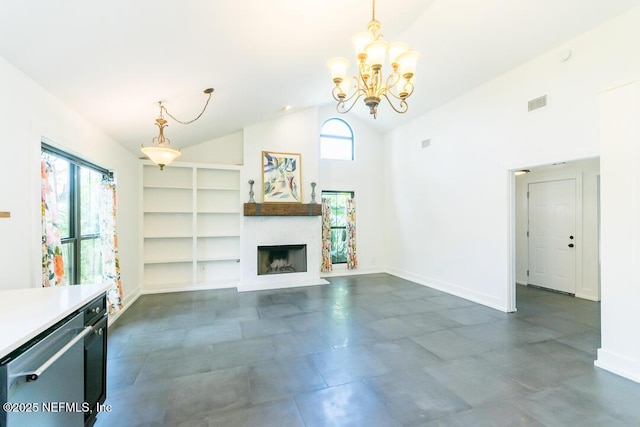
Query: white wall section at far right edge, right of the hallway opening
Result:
<box><xmin>596</xmin><ymin>78</ymin><xmax>640</xmax><ymax>382</ymax></box>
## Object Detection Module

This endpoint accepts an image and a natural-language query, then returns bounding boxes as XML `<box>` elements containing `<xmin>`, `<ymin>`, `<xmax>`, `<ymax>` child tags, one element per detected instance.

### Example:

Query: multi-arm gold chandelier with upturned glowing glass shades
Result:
<box><xmin>327</xmin><ymin>0</ymin><xmax>419</xmax><ymax>119</ymax></box>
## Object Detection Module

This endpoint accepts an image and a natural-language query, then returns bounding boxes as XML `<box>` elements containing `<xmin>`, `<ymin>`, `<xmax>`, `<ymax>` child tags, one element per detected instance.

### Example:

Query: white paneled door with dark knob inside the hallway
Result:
<box><xmin>529</xmin><ymin>179</ymin><xmax>577</xmax><ymax>294</ymax></box>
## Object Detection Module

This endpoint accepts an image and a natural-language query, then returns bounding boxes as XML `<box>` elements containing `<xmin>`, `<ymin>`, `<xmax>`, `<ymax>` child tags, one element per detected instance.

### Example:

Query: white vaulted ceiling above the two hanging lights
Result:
<box><xmin>0</xmin><ymin>0</ymin><xmax>640</xmax><ymax>154</ymax></box>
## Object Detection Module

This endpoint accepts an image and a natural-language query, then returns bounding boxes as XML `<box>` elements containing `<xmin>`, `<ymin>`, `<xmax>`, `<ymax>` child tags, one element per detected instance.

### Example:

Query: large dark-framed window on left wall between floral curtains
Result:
<box><xmin>41</xmin><ymin>144</ymin><xmax>109</xmax><ymax>285</ymax></box>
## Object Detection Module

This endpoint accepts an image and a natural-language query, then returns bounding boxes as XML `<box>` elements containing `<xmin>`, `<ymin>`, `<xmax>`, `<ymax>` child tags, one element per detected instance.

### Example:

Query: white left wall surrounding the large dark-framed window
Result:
<box><xmin>0</xmin><ymin>58</ymin><xmax>140</xmax><ymax>303</ymax></box>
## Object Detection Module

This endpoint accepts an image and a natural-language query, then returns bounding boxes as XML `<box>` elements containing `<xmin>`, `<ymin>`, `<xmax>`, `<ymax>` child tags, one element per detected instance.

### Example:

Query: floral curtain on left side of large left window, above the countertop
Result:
<box><xmin>40</xmin><ymin>159</ymin><xmax>67</xmax><ymax>287</ymax></box>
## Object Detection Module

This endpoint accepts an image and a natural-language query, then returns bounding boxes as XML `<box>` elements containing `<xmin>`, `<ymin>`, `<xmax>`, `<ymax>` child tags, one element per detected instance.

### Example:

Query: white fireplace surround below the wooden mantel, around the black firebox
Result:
<box><xmin>238</xmin><ymin>216</ymin><xmax>329</xmax><ymax>291</ymax></box>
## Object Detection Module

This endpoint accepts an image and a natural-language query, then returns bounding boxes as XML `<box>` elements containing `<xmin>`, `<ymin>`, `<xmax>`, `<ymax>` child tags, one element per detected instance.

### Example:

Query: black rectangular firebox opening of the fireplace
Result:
<box><xmin>258</xmin><ymin>244</ymin><xmax>307</xmax><ymax>276</ymax></box>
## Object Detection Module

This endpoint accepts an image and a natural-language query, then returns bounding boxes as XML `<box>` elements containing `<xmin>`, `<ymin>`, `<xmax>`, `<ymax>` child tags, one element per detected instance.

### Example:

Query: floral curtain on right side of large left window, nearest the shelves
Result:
<box><xmin>100</xmin><ymin>175</ymin><xmax>122</xmax><ymax>313</ymax></box>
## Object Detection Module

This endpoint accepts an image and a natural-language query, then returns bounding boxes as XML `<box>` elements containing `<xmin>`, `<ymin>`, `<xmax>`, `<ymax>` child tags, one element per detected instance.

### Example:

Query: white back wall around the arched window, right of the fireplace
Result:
<box><xmin>317</xmin><ymin>105</ymin><xmax>385</xmax><ymax>277</ymax></box>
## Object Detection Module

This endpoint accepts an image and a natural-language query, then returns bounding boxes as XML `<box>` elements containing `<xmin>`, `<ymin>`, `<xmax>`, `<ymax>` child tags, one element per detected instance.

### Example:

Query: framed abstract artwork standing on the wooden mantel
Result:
<box><xmin>262</xmin><ymin>151</ymin><xmax>302</xmax><ymax>203</ymax></box>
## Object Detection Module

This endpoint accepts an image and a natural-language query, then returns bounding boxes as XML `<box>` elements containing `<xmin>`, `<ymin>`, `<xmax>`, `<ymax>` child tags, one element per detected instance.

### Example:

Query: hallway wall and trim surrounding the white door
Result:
<box><xmin>515</xmin><ymin>159</ymin><xmax>600</xmax><ymax>301</ymax></box>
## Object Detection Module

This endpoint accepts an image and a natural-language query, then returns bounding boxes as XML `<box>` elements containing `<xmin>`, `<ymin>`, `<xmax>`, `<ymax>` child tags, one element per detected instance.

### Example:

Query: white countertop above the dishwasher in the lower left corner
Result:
<box><xmin>0</xmin><ymin>285</ymin><xmax>109</xmax><ymax>359</ymax></box>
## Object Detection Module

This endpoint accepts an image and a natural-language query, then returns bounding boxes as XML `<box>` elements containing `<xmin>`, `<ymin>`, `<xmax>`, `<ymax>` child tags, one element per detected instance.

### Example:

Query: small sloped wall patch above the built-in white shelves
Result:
<box><xmin>178</xmin><ymin>131</ymin><xmax>244</xmax><ymax>165</ymax></box>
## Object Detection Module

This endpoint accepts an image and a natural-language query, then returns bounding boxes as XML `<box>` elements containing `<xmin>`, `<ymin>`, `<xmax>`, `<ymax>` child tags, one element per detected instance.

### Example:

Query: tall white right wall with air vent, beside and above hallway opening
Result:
<box><xmin>384</xmin><ymin>8</ymin><xmax>640</xmax><ymax>314</ymax></box>
